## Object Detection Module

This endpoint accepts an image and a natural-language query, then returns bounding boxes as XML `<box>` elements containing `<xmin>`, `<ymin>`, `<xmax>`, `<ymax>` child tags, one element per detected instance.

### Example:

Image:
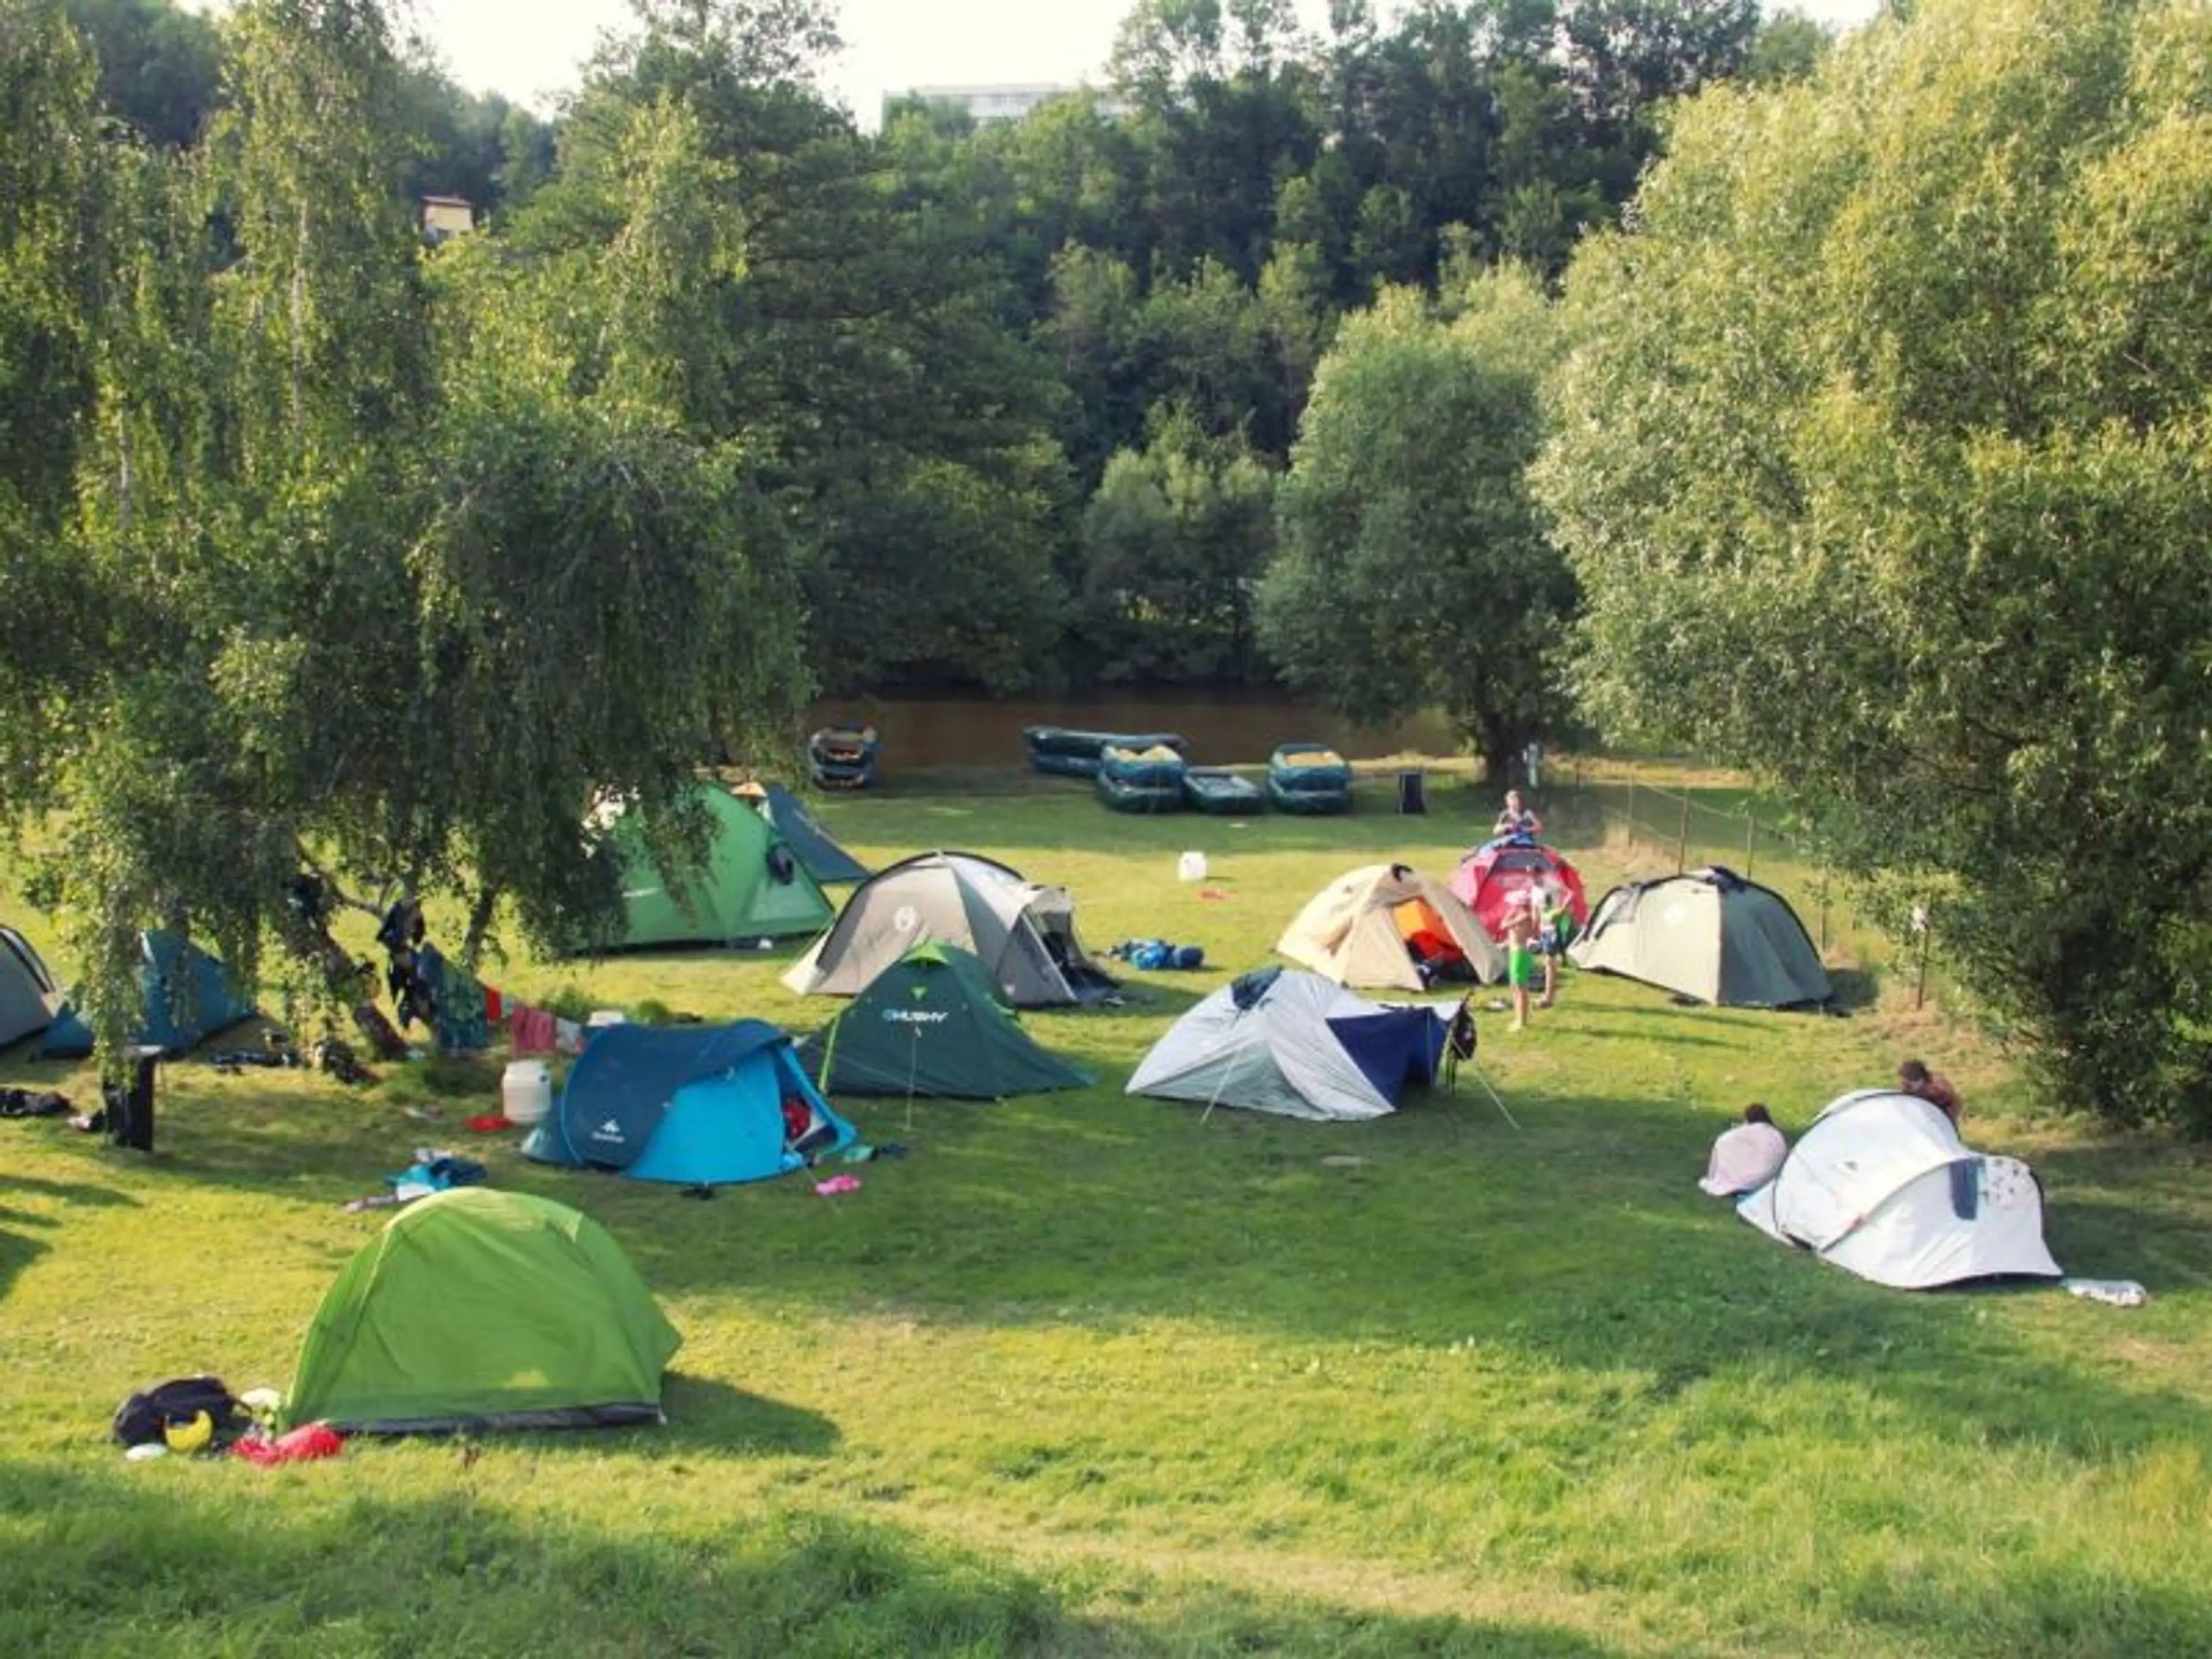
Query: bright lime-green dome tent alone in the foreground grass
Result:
<box><xmin>285</xmin><ymin>1188</ymin><xmax>684</xmax><ymax>1433</ymax></box>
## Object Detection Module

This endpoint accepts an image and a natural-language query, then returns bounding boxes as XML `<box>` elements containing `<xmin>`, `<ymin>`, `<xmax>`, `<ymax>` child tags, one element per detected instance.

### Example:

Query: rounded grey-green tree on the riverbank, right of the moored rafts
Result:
<box><xmin>1259</xmin><ymin>268</ymin><xmax>1575</xmax><ymax>777</ymax></box>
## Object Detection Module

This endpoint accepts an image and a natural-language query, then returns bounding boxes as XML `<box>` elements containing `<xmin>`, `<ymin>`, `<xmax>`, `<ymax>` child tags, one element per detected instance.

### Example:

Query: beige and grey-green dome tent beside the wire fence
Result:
<box><xmin>1566</xmin><ymin>865</ymin><xmax>1834</xmax><ymax>1009</ymax></box>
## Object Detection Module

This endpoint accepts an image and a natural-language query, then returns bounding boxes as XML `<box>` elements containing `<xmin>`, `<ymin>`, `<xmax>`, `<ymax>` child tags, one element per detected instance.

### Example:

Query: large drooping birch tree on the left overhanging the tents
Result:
<box><xmin>55</xmin><ymin>0</ymin><xmax>805</xmax><ymax>1048</ymax></box>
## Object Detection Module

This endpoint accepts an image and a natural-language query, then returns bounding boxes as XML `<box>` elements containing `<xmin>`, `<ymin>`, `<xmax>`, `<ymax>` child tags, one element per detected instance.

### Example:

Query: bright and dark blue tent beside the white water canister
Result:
<box><xmin>522</xmin><ymin>1020</ymin><xmax>856</xmax><ymax>1185</ymax></box>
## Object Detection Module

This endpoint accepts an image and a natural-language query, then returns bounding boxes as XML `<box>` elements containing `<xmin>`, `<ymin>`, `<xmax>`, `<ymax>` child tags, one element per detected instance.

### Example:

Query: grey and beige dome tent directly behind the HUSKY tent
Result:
<box><xmin>783</xmin><ymin>851</ymin><xmax>1115</xmax><ymax>1009</ymax></box>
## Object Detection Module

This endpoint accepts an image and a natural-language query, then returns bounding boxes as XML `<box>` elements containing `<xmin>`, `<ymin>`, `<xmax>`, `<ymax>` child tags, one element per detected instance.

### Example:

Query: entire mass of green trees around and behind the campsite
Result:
<box><xmin>0</xmin><ymin>0</ymin><xmax>2212</xmax><ymax>1126</ymax></box>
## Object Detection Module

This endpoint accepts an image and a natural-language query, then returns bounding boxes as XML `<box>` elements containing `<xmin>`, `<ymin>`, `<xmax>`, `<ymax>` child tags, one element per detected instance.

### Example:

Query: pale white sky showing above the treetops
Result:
<box><xmin>394</xmin><ymin>0</ymin><xmax>1878</xmax><ymax>128</ymax></box>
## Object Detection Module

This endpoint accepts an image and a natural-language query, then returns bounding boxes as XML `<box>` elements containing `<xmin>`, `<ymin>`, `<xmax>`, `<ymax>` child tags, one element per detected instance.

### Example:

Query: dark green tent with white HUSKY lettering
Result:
<box><xmin>798</xmin><ymin>940</ymin><xmax>1090</xmax><ymax>1099</ymax></box>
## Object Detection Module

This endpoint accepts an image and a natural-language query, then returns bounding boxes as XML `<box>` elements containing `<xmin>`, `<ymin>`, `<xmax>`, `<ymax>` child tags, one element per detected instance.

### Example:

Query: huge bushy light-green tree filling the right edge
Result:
<box><xmin>1540</xmin><ymin>0</ymin><xmax>2212</xmax><ymax>1130</ymax></box>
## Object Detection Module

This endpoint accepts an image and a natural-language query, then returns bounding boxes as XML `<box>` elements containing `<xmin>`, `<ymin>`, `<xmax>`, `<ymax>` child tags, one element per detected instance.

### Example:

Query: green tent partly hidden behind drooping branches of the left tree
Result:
<box><xmin>584</xmin><ymin>785</ymin><xmax>836</xmax><ymax>951</ymax></box>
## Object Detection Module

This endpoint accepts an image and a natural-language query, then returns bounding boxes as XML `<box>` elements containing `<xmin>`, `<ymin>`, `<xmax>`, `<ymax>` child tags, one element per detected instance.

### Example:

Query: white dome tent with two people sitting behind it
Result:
<box><xmin>1736</xmin><ymin>1088</ymin><xmax>2059</xmax><ymax>1290</ymax></box>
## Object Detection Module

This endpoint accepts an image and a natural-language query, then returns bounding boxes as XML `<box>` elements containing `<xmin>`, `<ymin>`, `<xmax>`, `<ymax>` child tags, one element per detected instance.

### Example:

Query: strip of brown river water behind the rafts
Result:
<box><xmin>808</xmin><ymin>692</ymin><xmax>1458</xmax><ymax>767</ymax></box>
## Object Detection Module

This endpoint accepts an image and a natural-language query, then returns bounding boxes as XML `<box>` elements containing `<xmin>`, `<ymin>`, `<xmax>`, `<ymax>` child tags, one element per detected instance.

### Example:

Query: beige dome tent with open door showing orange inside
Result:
<box><xmin>1274</xmin><ymin>865</ymin><xmax>1506</xmax><ymax>991</ymax></box>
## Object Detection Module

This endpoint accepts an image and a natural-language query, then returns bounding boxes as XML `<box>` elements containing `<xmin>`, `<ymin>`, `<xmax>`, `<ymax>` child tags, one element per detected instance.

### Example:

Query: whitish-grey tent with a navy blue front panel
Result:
<box><xmin>1128</xmin><ymin>969</ymin><xmax>1451</xmax><ymax>1122</ymax></box>
